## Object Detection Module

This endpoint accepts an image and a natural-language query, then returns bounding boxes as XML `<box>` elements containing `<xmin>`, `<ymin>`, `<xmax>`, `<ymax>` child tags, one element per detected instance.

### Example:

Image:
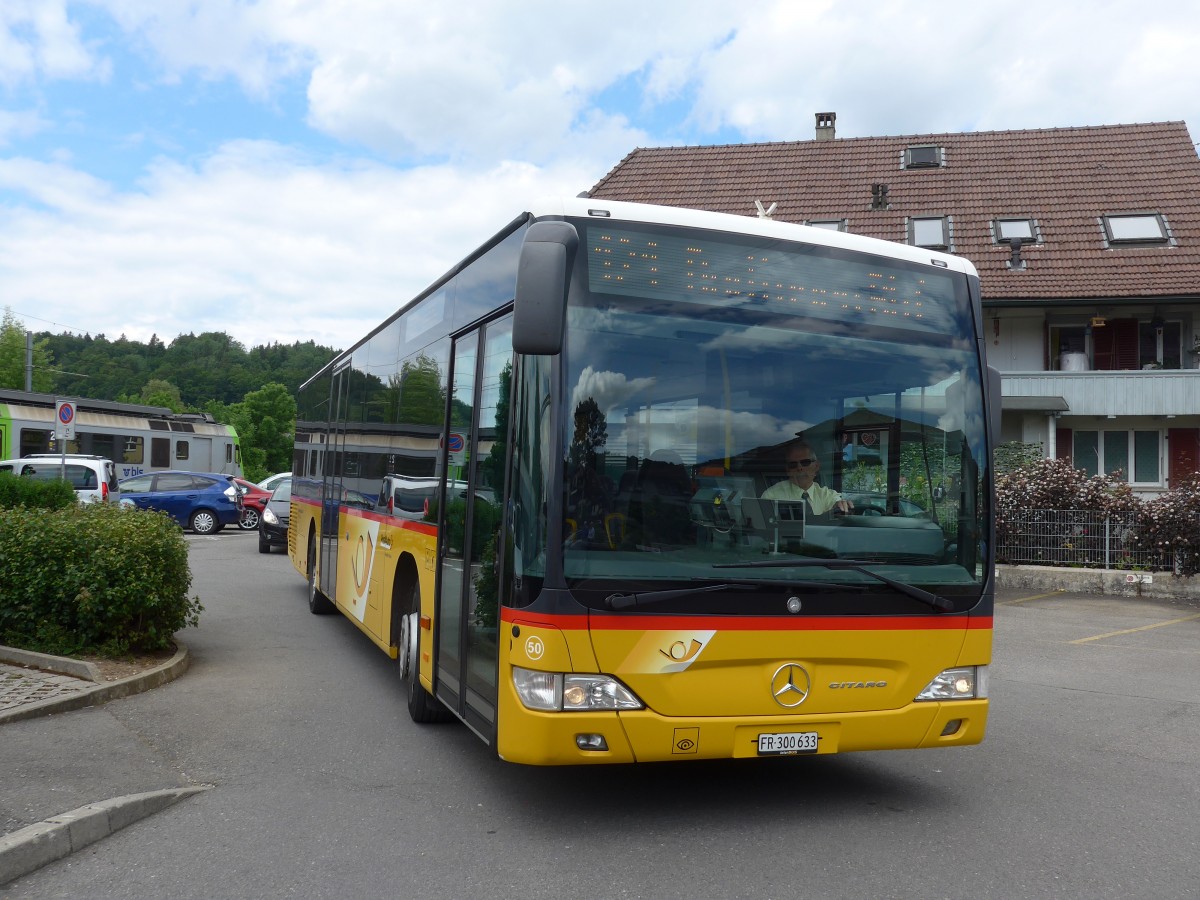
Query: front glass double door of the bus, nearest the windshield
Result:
<box><xmin>437</xmin><ymin>316</ymin><xmax>512</xmax><ymax>739</ymax></box>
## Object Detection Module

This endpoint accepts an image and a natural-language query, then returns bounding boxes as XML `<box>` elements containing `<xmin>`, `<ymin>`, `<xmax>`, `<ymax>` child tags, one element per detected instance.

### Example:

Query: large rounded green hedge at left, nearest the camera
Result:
<box><xmin>0</xmin><ymin>503</ymin><xmax>203</xmax><ymax>656</ymax></box>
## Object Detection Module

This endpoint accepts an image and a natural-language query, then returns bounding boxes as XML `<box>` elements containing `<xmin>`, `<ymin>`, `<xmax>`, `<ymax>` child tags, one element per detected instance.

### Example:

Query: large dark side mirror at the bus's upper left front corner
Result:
<box><xmin>512</xmin><ymin>222</ymin><xmax>580</xmax><ymax>356</ymax></box>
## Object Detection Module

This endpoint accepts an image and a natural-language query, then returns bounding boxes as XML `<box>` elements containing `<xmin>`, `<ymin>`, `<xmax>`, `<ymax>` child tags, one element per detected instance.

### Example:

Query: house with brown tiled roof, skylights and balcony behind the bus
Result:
<box><xmin>590</xmin><ymin>113</ymin><xmax>1200</xmax><ymax>493</ymax></box>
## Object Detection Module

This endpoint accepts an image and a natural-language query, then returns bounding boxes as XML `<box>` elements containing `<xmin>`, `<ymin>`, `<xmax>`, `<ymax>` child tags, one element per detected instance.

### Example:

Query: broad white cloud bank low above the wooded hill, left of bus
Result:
<box><xmin>0</xmin><ymin>142</ymin><xmax>590</xmax><ymax>347</ymax></box>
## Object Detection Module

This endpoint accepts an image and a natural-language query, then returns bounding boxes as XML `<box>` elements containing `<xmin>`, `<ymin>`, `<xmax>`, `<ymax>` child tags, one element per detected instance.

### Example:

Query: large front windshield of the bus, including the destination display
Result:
<box><xmin>549</xmin><ymin>222</ymin><xmax>989</xmax><ymax>614</ymax></box>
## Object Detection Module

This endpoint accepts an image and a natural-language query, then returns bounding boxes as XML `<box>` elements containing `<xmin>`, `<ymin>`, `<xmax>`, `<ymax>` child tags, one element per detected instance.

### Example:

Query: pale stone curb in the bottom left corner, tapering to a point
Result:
<box><xmin>0</xmin><ymin>785</ymin><xmax>212</xmax><ymax>886</ymax></box>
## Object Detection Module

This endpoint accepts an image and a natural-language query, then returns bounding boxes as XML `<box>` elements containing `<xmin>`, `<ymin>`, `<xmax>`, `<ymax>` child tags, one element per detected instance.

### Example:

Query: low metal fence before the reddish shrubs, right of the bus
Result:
<box><xmin>996</xmin><ymin>509</ymin><xmax>1175</xmax><ymax>571</ymax></box>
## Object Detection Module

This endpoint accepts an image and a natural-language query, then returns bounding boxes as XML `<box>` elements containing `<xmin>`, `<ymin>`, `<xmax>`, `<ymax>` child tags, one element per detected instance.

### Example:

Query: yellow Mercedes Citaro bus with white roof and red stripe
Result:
<box><xmin>288</xmin><ymin>198</ymin><xmax>1000</xmax><ymax>764</ymax></box>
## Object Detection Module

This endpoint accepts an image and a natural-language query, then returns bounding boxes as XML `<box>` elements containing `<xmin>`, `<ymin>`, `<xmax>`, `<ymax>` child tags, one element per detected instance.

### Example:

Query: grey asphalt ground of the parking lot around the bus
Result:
<box><xmin>5</xmin><ymin>529</ymin><xmax>1200</xmax><ymax>900</ymax></box>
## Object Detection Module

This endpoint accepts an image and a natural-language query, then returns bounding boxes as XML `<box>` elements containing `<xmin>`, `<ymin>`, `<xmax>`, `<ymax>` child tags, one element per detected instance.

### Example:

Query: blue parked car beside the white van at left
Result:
<box><xmin>121</xmin><ymin>472</ymin><xmax>241</xmax><ymax>534</ymax></box>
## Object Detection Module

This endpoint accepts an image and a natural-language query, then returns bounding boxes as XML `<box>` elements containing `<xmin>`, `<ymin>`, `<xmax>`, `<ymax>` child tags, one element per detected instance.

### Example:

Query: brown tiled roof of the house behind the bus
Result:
<box><xmin>592</xmin><ymin>121</ymin><xmax>1200</xmax><ymax>302</ymax></box>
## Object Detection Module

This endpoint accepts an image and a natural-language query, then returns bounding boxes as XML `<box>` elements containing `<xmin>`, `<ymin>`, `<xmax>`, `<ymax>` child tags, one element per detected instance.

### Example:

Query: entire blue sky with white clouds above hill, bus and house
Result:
<box><xmin>0</xmin><ymin>0</ymin><xmax>1200</xmax><ymax>347</ymax></box>
